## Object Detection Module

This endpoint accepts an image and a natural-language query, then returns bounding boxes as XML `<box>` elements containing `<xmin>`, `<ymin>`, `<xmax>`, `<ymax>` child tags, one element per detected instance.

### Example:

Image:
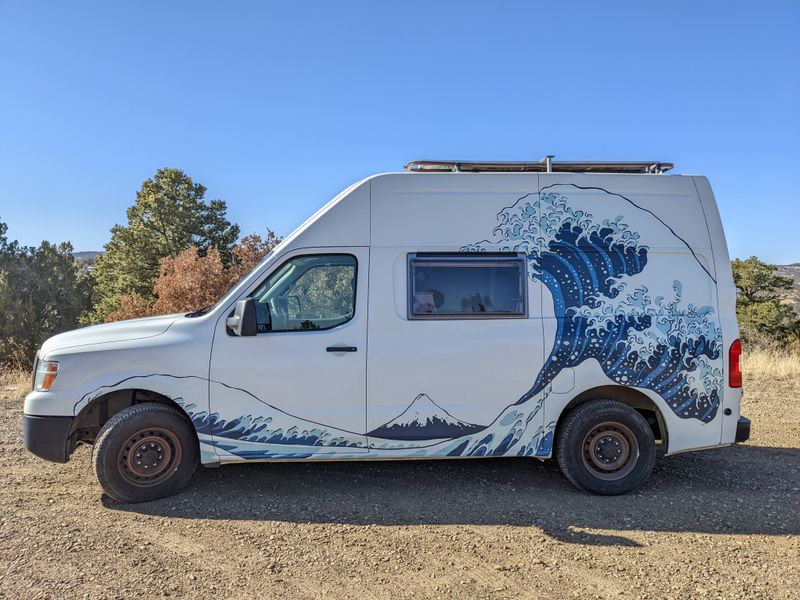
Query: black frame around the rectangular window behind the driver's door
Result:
<box><xmin>405</xmin><ymin>252</ymin><xmax>529</xmax><ymax>321</ymax></box>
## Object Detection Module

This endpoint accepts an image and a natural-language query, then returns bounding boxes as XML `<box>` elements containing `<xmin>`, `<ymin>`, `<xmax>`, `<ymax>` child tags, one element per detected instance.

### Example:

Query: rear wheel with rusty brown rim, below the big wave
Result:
<box><xmin>556</xmin><ymin>400</ymin><xmax>656</xmax><ymax>496</ymax></box>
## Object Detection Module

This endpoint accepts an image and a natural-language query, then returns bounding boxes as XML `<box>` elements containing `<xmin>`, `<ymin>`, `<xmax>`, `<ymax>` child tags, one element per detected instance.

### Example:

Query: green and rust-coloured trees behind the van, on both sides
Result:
<box><xmin>0</xmin><ymin>168</ymin><xmax>800</xmax><ymax>368</ymax></box>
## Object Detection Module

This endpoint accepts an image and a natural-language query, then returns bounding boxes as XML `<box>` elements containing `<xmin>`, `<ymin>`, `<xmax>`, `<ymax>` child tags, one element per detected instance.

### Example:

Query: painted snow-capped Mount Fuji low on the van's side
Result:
<box><xmin>367</xmin><ymin>394</ymin><xmax>485</xmax><ymax>440</ymax></box>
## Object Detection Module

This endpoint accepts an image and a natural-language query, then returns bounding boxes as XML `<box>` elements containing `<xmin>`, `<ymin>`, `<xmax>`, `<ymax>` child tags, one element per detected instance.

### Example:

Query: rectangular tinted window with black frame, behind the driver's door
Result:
<box><xmin>408</xmin><ymin>253</ymin><xmax>527</xmax><ymax>319</ymax></box>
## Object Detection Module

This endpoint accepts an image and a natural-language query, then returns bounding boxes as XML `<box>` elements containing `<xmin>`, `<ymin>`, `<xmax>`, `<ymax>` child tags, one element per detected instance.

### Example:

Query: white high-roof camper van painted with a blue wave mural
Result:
<box><xmin>24</xmin><ymin>157</ymin><xmax>750</xmax><ymax>501</ymax></box>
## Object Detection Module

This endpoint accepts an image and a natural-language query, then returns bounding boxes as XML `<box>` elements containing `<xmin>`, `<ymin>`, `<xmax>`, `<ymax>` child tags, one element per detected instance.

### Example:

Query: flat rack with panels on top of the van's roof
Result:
<box><xmin>404</xmin><ymin>154</ymin><xmax>675</xmax><ymax>175</ymax></box>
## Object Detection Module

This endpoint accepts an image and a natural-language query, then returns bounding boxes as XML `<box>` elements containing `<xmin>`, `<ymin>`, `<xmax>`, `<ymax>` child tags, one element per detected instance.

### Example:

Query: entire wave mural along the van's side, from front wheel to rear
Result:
<box><xmin>169</xmin><ymin>184</ymin><xmax>722</xmax><ymax>458</ymax></box>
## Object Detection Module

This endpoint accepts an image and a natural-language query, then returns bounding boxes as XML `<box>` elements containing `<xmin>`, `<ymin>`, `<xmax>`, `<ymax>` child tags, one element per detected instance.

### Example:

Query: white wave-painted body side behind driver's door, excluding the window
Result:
<box><xmin>367</xmin><ymin>173</ymin><xmax>727</xmax><ymax>457</ymax></box>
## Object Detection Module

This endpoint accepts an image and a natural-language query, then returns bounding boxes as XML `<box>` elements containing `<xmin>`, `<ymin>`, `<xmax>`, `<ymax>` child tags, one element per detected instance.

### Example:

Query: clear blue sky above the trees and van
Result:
<box><xmin>0</xmin><ymin>0</ymin><xmax>800</xmax><ymax>263</ymax></box>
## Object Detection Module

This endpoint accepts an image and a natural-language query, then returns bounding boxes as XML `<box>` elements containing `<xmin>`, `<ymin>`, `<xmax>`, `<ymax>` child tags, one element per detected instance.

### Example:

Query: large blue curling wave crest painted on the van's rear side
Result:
<box><xmin>464</xmin><ymin>186</ymin><xmax>722</xmax><ymax>422</ymax></box>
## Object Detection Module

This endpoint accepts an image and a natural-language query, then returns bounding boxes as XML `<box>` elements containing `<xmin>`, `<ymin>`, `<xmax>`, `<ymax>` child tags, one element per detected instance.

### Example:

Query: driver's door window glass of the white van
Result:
<box><xmin>253</xmin><ymin>254</ymin><xmax>357</xmax><ymax>333</ymax></box>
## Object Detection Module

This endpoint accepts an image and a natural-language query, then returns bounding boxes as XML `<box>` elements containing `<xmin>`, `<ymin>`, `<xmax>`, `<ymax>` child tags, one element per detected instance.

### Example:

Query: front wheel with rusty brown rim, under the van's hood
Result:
<box><xmin>92</xmin><ymin>402</ymin><xmax>199</xmax><ymax>502</ymax></box>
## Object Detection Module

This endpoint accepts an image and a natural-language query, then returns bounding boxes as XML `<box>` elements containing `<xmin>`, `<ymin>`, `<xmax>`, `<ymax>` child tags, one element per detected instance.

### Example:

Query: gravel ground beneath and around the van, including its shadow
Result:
<box><xmin>0</xmin><ymin>379</ymin><xmax>800</xmax><ymax>599</ymax></box>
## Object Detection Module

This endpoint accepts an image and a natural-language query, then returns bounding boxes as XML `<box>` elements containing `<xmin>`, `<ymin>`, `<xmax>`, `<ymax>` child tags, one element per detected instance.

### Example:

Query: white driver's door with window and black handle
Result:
<box><xmin>210</xmin><ymin>248</ymin><xmax>369</xmax><ymax>458</ymax></box>
